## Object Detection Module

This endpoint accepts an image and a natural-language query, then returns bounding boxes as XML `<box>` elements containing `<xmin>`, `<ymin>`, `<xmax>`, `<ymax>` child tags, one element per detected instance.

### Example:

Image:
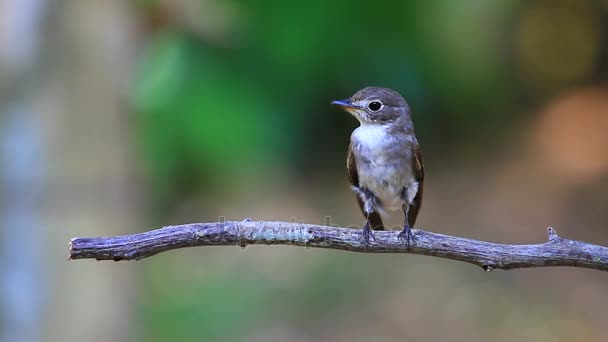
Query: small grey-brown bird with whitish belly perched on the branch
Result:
<box><xmin>332</xmin><ymin>87</ymin><xmax>424</xmax><ymax>248</ymax></box>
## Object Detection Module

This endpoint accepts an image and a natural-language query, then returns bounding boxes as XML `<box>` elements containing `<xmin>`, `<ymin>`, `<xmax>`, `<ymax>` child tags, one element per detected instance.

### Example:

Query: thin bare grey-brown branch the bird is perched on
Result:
<box><xmin>70</xmin><ymin>219</ymin><xmax>608</xmax><ymax>271</ymax></box>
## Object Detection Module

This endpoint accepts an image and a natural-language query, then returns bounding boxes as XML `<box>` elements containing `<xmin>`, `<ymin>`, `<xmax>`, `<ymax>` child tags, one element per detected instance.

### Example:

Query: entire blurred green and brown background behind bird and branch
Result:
<box><xmin>0</xmin><ymin>0</ymin><xmax>608</xmax><ymax>342</ymax></box>
